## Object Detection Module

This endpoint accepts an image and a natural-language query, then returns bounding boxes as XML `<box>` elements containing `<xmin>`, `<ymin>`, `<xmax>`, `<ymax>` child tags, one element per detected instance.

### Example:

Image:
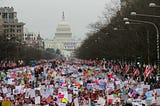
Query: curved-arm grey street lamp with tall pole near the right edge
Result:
<box><xmin>123</xmin><ymin>18</ymin><xmax>160</xmax><ymax>73</ymax></box>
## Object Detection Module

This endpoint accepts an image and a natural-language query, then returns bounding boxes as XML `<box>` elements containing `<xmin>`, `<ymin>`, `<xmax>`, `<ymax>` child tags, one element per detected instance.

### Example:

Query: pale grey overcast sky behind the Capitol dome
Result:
<box><xmin>0</xmin><ymin>0</ymin><xmax>117</xmax><ymax>39</ymax></box>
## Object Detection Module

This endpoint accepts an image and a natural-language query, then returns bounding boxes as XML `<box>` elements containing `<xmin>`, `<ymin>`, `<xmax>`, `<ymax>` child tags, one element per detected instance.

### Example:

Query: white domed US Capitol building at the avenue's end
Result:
<box><xmin>44</xmin><ymin>12</ymin><xmax>81</xmax><ymax>57</ymax></box>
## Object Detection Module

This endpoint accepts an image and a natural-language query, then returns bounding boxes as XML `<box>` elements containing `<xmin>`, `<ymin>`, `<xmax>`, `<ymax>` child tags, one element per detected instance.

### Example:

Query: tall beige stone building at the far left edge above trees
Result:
<box><xmin>0</xmin><ymin>7</ymin><xmax>25</xmax><ymax>41</ymax></box>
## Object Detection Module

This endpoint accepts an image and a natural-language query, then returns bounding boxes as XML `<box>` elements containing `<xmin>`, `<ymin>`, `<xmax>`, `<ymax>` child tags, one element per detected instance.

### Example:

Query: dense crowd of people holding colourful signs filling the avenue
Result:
<box><xmin>0</xmin><ymin>61</ymin><xmax>160</xmax><ymax>106</ymax></box>
